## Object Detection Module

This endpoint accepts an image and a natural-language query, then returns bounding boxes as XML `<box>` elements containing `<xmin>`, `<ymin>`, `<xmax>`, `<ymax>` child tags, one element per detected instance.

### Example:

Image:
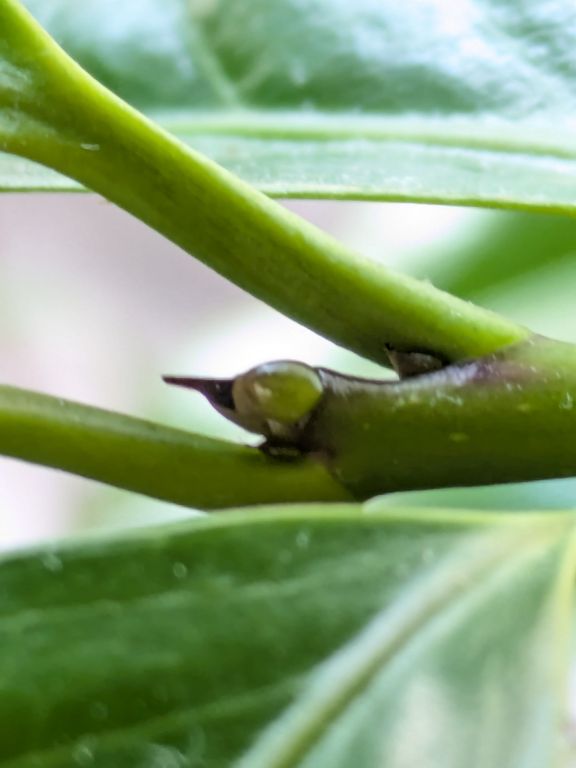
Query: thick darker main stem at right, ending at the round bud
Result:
<box><xmin>308</xmin><ymin>337</ymin><xmax>576</xmax><ymax>498</ymax></box>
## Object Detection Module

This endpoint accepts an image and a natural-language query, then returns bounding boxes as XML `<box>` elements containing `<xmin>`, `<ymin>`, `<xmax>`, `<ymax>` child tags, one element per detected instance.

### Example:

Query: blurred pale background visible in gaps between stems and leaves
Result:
<box><xmin>0</xmin><ymin>194</ymin><xmax>576</xmax><ymax>550</ymax></box>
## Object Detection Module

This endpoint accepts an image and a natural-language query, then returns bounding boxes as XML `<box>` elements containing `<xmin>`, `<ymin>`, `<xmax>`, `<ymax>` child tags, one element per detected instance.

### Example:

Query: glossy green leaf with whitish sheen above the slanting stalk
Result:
<box><xmin>0</xmin><ymin>0</ymin><xmax>576</xmax><ymax>211</ymax></box>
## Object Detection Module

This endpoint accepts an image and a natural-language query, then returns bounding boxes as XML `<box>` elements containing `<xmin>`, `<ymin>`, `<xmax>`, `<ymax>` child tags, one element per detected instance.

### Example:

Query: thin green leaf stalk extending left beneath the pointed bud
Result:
<box><xmin>0</xmin><ymin>387</ymin><xmax>350</xmax><ymax>509</ymax></box>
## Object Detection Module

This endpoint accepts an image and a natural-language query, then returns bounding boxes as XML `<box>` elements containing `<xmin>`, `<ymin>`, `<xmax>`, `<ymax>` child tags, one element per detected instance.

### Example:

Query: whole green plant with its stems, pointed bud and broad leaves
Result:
<box><xmin>0</xmin><ymin>0</ymin><xmax>576</xmax><ymax>768</ymax></box>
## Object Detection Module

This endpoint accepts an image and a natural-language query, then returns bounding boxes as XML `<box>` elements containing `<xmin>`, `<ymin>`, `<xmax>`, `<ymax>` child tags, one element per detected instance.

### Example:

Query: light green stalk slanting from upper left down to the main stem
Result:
<box><xmin>0</xmin><ymin>0</ymin><xmax>526</xmax><ymax>362</ymax></box>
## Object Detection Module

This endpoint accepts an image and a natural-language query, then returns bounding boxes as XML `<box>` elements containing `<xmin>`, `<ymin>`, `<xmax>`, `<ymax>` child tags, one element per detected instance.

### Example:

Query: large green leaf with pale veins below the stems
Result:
<box><xmin>0</xmin><ymin>504</ymin><xmax>575</xmax><ymax>768</ymax></box>
